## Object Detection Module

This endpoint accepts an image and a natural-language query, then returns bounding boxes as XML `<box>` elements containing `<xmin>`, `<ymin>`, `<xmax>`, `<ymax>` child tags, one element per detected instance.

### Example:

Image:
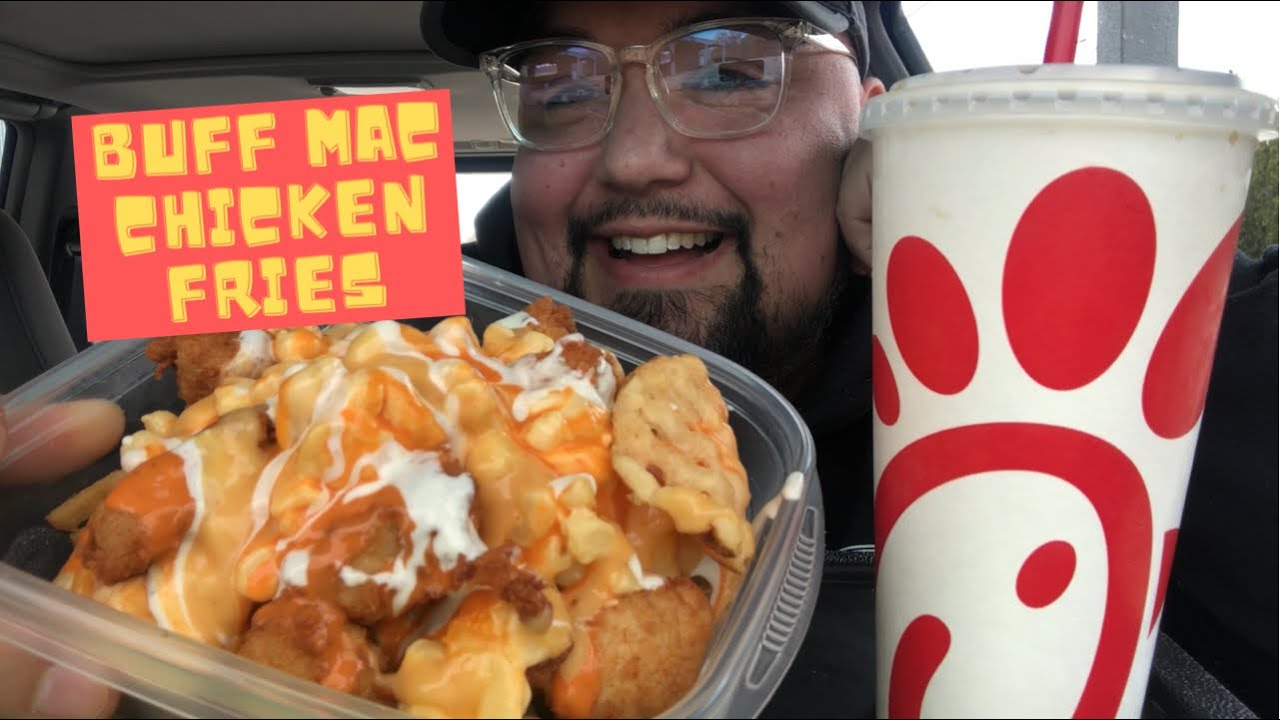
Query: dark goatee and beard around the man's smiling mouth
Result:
<box><xmin>561</xmin><ymin>197</ymin><xmax>852</xmax><ymax>401</ymax></box>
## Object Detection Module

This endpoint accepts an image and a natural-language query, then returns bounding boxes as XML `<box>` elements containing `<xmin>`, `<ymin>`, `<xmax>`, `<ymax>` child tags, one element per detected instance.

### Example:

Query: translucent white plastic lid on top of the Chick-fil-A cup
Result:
<box><xmin>860</xmin><ymin>64</ymin><xmax>1277</xmax><ymax>140</ymax></box>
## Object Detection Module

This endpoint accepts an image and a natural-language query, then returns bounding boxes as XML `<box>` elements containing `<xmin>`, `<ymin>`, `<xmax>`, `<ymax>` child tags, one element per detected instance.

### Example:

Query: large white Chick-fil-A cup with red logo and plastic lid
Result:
<box><xmin>861</xmin><ymin>64</ymin><xmax>1276</xmax><ymax>717</ymax></box>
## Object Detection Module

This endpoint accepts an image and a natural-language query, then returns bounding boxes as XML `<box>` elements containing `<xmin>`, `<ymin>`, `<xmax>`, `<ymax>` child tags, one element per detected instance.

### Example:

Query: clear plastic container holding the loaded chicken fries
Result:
<box><xmin>0</xmin><ymin>259</ymin><xmax>824</xmax><ymax>717</ymax></box>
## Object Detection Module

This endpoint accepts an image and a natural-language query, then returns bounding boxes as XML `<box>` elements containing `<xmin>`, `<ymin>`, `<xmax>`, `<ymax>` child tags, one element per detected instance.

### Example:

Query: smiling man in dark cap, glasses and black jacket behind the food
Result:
<box><xmin>422</xmin><ymin>3</ymin><xmax>1277</xmax><ymax>715</ymax></box>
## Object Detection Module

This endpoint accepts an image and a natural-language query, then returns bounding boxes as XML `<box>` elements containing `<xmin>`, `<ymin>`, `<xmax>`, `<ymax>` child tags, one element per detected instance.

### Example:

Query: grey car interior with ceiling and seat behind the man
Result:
<box><xmin>0</xmin><ymin>0</ymin><xmax>1249</xmax><ymax>717</ymax></box>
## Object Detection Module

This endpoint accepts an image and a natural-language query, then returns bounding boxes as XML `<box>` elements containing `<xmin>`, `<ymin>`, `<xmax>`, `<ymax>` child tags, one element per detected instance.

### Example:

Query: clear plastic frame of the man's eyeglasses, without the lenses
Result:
<box><xmin>480</xmin><ymin>18</ymin><xmax>859</xmax><ymax>152</ymax></box>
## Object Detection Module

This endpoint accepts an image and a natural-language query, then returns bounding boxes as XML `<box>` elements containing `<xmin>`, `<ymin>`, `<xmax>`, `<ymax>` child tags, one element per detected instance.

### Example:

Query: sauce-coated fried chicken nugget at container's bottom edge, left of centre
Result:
<box><xmin>237</xmin><ymin>596</ymin><xmax>390</xmax><ymax>702</ymax></box>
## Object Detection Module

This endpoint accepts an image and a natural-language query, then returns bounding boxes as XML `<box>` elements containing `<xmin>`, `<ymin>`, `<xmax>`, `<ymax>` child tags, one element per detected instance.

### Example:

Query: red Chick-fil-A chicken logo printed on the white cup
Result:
<box><xmin>872</xmin><ymin>167</ymin><xmax>1239</xmax><ymax>717</ymax></box>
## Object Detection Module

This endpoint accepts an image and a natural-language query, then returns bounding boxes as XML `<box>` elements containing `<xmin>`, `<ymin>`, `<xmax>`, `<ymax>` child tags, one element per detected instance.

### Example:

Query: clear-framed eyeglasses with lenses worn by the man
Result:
<box><xmin>480</xmin><ymin>18</ymin><xmax>856</xmax><ymax>150</ymax></box>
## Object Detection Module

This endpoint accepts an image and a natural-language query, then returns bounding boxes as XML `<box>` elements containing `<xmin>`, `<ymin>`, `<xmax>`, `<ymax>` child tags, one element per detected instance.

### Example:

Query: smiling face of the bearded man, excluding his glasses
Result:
<box><xmin>511</xmin><ymin>3</ymin><xmax>879</xmax><ymax>387</ymax></box>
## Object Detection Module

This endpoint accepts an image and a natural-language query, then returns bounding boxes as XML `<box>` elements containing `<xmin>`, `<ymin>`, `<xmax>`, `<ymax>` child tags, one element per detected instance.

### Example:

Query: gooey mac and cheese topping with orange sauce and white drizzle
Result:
<box><xmin>58</xmin><ymin>313</ymin><xmax>747</xmax><ymax>717</ymax></box>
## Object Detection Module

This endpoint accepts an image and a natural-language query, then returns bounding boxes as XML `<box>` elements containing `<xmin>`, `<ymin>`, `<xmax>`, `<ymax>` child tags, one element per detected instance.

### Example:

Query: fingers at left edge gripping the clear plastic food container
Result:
<box><xmin>0</xmin><ymin>400</ymin><xmax>124</xmax><ymax>717</ymax></box>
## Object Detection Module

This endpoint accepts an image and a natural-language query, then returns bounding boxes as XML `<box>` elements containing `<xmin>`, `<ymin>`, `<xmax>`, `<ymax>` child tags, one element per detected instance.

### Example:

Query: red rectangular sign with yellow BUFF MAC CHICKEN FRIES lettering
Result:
<box><xmin>72</xmin><ymin>91</ymin><xmax>465</xmax><ymax>342</ymax></box>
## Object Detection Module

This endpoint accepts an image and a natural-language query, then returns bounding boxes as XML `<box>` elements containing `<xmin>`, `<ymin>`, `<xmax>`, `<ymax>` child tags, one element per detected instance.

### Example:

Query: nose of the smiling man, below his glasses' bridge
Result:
<box><xmin>596</xmin><ymin>65</ymin><xmax>692</xmax><ymax>193</ymax></box>
